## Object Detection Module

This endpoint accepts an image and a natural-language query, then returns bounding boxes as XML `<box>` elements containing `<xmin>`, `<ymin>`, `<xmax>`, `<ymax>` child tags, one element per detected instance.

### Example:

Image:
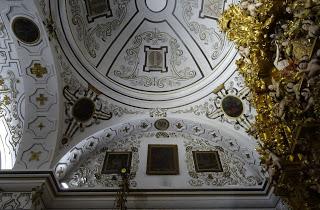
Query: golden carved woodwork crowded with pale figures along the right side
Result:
<box><xmin>220</xmin><ymin>0</ymin><xmax>320</xmax><ymax>210</ymax></box>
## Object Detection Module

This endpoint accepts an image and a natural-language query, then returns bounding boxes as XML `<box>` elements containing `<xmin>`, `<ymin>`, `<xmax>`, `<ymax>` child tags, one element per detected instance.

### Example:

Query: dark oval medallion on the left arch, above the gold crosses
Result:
<box><xmin>12</xmin><ymin>17</ymin><xmax>40</xmax><ymax>44</ymax></box>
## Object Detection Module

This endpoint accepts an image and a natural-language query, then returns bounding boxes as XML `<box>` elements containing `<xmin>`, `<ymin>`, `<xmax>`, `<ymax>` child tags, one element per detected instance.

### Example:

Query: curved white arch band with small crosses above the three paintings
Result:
<box><xmin>54</xmin><ymin>117</ymin><xmax>261</xmax><ymax>187</ymax></box>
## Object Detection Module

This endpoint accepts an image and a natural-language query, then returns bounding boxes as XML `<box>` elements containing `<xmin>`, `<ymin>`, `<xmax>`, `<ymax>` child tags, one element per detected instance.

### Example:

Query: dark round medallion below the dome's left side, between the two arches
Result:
<box><xmin>72</xmin><ymin>98</ymin><xmax>95</xmax><ymax>122</ymax></box>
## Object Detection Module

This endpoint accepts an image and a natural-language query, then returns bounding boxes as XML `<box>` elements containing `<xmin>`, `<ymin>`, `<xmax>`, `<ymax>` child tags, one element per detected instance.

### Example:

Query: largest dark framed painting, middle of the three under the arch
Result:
<box><xmin>147</xmin><ymin>144</ymin><xmax>179</xmax><ymax>175</ymax></box>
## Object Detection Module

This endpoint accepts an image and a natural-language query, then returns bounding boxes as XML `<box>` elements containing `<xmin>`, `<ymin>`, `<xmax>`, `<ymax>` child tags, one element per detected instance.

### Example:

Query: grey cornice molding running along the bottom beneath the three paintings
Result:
<box><xmin>0</xmin><ymin>171</ymin><xmax>279</xmax><ymax>210</ymax></box>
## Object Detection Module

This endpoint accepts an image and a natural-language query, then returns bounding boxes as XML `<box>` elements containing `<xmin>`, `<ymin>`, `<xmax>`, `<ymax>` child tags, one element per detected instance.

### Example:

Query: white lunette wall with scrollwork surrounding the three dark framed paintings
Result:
<box><xmin>56</xmin><ymin>131</ymin><xmax>265</xmax><ymax>189</ymax></box>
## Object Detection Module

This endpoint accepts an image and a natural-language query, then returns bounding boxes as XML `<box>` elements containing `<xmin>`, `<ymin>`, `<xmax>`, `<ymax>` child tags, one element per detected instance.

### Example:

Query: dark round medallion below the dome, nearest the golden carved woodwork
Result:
<box><xmin>221</xmin><ymin>96</ymin><xmax>243</xmax><ymax>117</ymax></box>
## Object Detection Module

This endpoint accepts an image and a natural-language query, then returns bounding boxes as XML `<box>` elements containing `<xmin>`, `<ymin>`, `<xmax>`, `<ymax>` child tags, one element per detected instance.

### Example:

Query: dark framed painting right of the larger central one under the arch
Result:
<box><xmin>192</xmin><ymin>151</ymin><xmax>223</xmax><ymax>172</ymax></box>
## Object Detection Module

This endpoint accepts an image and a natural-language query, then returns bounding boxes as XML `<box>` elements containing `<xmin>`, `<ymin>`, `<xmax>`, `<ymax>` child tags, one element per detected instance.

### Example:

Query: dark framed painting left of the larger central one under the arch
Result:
<box><xmin>101</xmin><ymin>152</ymin><xmax>132</xmax><ymax>174</ymax></box>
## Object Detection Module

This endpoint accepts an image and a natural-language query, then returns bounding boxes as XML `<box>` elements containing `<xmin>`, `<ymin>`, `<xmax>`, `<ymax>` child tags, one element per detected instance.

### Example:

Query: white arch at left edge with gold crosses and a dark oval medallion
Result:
<box><xmin>0</xmin><ymin>1</ymin><xmax>60</xmax><ymax>169</ymax></box>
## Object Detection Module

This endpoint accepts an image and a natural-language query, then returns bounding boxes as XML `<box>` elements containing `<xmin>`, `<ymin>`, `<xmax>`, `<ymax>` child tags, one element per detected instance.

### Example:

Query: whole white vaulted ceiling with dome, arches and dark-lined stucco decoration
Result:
<box><xmin>0</xmin><ymin>0</ymin><xmax>267</xmax><ymax>195</ymax></box>
